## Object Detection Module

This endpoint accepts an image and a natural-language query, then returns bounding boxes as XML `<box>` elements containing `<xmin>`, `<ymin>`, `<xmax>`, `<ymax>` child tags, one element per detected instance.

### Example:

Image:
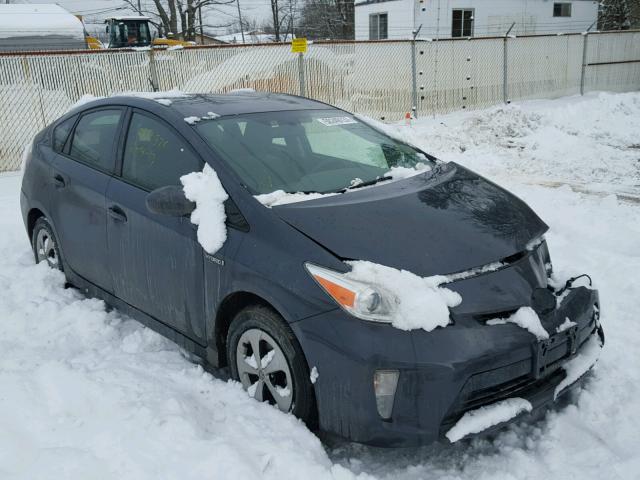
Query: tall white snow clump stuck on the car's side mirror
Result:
<box><xmin>180</xmin><ymin>164</ymin><xmax>229</xmax><ymax>255</ymax></box>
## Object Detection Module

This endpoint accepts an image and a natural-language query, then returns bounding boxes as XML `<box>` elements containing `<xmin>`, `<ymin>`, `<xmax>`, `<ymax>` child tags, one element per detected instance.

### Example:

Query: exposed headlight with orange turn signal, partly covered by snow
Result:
<box><xmin>305</xmin><ymin>263</ymin><xmax>398</xmax><ymax>323</ymax></box>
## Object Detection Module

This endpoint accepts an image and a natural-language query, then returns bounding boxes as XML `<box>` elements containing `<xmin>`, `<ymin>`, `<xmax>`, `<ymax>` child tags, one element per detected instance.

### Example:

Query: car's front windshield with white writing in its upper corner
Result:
<box><xmin>197</xmin><ymin>110</ymin><xmax>431</xmax><ymax>194</ymax></box>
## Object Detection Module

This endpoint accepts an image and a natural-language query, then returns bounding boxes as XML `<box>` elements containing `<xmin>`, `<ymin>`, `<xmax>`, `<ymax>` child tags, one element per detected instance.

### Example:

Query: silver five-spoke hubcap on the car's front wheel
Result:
<box><xmin>236</xmin><ymin>328</ymin><xmax>293</xmax><ymax>412</ymax></box>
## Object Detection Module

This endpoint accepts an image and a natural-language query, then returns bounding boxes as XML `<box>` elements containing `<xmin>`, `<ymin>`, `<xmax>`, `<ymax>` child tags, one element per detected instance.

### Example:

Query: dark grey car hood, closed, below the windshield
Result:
<box><xmin>273</xmin><ymin>163</ymin><xmax>548</xmax><ymax>276</ymax></box>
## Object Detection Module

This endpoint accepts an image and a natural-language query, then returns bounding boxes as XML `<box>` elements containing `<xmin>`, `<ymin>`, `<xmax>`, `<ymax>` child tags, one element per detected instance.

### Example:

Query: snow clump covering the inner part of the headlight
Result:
<box><xmin>345</xmin><ymin>261</ymin><xmax>462</xmax><ymax>332</ymax></box>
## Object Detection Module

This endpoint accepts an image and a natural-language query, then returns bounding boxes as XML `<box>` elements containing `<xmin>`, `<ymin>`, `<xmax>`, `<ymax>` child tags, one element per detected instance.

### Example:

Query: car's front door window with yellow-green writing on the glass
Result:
<box><xmin>122</xmin><ymin>112</ymin><xmax>203</xmax><ymax>190</ymax></box>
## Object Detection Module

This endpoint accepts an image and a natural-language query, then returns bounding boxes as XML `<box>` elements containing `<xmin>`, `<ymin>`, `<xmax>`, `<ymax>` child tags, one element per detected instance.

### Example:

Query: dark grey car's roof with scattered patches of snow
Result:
<box><xmin>85</xmin><ymin>91</ymin><xmax>335</xmax><ymax>118</ymax></box>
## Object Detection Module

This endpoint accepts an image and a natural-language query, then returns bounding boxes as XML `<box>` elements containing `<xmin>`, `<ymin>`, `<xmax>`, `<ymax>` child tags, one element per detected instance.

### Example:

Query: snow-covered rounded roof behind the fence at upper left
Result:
<box><xmin>0</xmin><ymin>4</ymin><xmax>84</xmax><ymax>40</ymax></box>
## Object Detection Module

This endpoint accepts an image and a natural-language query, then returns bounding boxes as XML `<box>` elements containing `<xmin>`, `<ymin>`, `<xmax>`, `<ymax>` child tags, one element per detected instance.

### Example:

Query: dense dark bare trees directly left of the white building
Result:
<box><xmin>299</xmin><ymin>0</ymin><xmax>354</xmax><ymax>39</ymax></box>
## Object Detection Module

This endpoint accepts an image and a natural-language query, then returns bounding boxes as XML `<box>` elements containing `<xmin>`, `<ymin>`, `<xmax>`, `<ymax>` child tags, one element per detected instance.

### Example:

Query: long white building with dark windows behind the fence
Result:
<box><xmin>355</xmin><ymin>0</ymin><xmax>598</xmax><ymax>40</ymax></box>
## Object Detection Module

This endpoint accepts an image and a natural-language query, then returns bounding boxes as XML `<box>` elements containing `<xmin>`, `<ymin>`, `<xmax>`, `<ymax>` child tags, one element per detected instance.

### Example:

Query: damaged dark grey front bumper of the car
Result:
<box><xmin>291</xmin><ymin>287</ymin><xmax>602</xmax><ymax>446</ymax></box>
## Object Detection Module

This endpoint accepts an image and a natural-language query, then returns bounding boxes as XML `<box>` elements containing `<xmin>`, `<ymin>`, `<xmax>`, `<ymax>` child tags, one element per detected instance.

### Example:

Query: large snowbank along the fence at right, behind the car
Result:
<box><xmin>382</xmin><ymin>92</ymin><xmax>640</xmax><ymax>190</ymax></box>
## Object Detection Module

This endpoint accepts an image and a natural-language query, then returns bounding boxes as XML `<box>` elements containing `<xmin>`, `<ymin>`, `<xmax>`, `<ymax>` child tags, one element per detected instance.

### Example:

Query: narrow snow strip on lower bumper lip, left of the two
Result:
<box><xmin>445</xmin><ymin>398</ymin><xmax>533</xmax><ymax>443</ymax></box>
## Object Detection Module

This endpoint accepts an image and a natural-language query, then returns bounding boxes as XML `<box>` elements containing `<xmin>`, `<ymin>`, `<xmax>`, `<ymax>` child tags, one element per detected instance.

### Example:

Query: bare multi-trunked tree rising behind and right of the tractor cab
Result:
<box><xmin>125</xmin><ymin>0</ymin><xmax>236</xmax><ymax>40</ymax></box>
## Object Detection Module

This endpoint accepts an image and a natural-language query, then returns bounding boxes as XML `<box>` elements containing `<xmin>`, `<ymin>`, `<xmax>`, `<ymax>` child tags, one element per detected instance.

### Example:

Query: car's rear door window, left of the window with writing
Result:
<box><xmin>69</xmin><ymin>109</ymin><xmax>122</xmax><ymax>172</ymax></box>
